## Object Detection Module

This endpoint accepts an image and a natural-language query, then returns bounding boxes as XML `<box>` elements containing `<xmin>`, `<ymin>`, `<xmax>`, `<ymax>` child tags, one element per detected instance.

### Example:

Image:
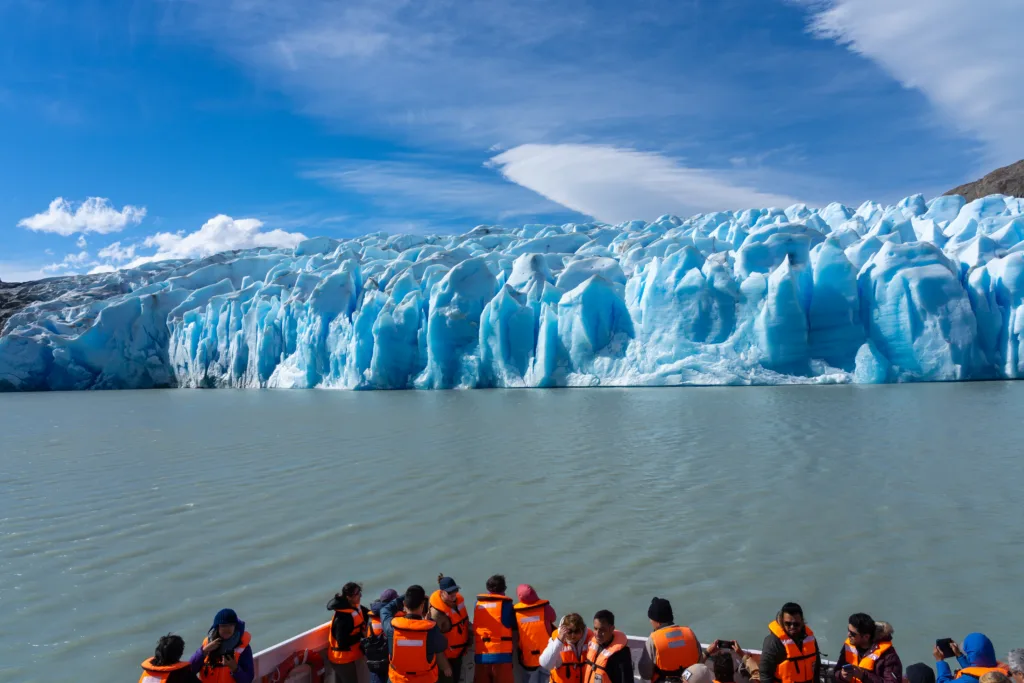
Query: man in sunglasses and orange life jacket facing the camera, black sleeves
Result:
<box><xmin>759</xmin><ymin>602</ymin><xmax>821</xmax><ymax>683</ymax></box>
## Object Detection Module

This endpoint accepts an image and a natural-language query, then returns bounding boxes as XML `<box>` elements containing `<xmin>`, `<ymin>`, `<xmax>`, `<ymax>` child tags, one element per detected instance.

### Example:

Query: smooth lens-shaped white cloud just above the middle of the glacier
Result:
<box><xmin>489</xmin><ymin>144</ymin><xmax>797</xmax><ymax>223</ymax></box>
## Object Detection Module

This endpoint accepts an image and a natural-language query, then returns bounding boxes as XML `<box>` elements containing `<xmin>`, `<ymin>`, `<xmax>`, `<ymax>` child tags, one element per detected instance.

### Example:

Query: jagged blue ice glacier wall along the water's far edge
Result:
<box><xmin>0</xmin><ymin>195</ymin><xmax>1024</xmax><ymax>391</ymax></box>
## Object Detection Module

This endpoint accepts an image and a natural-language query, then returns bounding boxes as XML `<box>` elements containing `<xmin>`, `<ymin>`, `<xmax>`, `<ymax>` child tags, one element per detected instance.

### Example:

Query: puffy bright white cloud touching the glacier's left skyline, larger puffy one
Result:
<box><xmin>128</xmin><ymin>214</ymin><xmax>306</xmax><ymax>267</ymax></box>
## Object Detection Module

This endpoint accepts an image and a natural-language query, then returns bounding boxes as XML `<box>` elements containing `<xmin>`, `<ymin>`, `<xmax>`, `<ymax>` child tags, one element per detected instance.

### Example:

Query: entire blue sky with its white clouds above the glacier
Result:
<box><xmin>0</xmin><ymin>0</ymin><xmax>1024</xmax><ymax>281</ymax></box>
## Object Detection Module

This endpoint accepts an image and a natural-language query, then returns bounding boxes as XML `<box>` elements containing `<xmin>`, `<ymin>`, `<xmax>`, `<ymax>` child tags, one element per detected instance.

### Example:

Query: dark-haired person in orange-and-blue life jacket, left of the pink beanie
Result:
<box><xmin>473</xmin><ymin>573</ymin><xmax>515</xmax><ymax>683</ymax></box>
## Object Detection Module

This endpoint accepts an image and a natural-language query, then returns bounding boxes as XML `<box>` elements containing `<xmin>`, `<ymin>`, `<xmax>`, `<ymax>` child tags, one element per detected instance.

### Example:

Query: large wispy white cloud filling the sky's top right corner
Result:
<box><xmin>804</xmin><ymin>0</ymin><xmax>1024</xmax><ymax>164</ymax></box>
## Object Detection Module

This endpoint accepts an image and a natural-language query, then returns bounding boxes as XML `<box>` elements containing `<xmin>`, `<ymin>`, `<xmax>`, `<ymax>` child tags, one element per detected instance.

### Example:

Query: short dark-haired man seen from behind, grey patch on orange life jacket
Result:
<box><xmin>381</xmin><ymin>586</ymin><xmax>452</xmax><ymax>683</ymax></box>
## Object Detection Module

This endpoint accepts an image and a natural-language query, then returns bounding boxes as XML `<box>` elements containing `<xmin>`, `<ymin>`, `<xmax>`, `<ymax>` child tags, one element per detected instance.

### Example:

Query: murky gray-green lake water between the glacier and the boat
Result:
<box><xmin>0</xmin><ymin>383</ymin><xmax>1024</xmax><ymax>682</ymax></box>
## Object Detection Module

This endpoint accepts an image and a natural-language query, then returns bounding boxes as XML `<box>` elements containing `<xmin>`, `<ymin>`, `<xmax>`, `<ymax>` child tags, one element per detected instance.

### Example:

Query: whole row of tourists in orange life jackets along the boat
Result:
<box><xmin>139</xmin><ymin>574</ymin><xmax>1024</xmax><ymax>683</ymax></box>
